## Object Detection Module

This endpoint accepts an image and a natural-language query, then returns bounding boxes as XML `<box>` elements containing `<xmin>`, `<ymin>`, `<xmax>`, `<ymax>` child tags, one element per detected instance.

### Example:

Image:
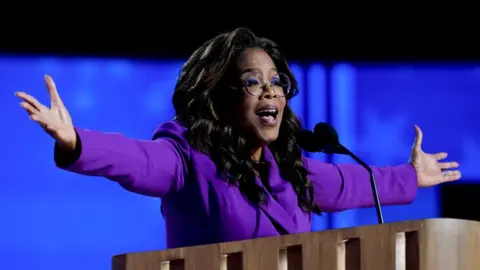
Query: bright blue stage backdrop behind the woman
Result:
<box><xmin>0</xmin><ymin>57</ymin><xmax>480</xmax><ymax>270</ymax></box>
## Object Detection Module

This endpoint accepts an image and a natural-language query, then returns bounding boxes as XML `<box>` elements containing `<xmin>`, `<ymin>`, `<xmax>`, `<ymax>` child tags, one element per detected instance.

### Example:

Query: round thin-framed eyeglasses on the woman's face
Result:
<box><xmin>238</xmin><ymin>73</ymin><xmax>291</xmax><ymax>97</ymax></box>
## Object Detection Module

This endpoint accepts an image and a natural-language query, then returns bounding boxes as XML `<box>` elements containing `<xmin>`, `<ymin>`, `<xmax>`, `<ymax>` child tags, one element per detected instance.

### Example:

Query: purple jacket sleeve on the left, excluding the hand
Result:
<box><xmin>55</xmin><ymin>128</ymin><xmax>187</xmax><ymax>197</ymax></box>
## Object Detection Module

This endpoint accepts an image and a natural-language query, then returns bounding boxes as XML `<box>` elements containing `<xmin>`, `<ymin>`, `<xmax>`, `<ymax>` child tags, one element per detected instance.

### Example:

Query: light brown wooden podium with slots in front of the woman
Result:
<box><xmin>112</xmin><ymin>219</ymin><xmax>480</xmax><ymax>270</ymax></box>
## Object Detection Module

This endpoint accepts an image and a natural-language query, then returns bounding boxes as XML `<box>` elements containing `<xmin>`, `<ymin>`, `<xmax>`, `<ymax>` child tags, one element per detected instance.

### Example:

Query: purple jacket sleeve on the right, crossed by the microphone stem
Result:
<box><xmin>304</xmin><ymin>158</ymin><xmax>418</xmax><ymax>212</ymax></box>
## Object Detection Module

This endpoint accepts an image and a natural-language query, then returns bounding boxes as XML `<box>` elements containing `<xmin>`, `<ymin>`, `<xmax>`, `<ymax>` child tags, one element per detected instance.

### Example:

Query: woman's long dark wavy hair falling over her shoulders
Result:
<box><xmin>173</xmin><ymin>28</ymin><xmax>320</xmax><ymax>213</ymax></box>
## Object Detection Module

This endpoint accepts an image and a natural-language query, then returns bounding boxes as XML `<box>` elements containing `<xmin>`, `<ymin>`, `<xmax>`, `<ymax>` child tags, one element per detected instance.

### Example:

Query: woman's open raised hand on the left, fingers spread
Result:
<box><xmin>15</xmin><ymin>75</ymin><xmax>77</xmax><ymax>151</ymax></box>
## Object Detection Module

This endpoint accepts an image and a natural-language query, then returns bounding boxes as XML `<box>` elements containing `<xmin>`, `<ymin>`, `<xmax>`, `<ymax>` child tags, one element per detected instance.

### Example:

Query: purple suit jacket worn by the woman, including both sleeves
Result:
<box><xmin>56</xmin><ymin>121</ymin><xmax>417</xmax><ymax>248</ymax></box>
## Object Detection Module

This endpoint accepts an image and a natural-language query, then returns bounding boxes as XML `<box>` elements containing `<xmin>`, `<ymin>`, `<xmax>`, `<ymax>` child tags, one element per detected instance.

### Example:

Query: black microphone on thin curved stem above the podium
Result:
<box><xmin>297</xmin><ymin>123</ymin><xmax>384</xmax><ymax>224</ymax></box>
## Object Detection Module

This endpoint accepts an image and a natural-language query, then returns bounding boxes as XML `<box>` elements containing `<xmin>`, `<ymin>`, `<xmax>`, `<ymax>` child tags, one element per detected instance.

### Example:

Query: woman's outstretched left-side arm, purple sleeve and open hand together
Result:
<box><xmin>15</xmin><ymin>75</ymin><xmax>187</xmax><ymax>197</ymax></box>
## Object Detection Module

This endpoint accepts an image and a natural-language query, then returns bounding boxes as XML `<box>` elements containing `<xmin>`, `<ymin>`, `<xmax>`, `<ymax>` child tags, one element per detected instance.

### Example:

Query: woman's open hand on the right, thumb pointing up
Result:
<box><xmin>410</xmin><ymin>125</ymin><xmax>462</xmax><ymax>187</ymax></box>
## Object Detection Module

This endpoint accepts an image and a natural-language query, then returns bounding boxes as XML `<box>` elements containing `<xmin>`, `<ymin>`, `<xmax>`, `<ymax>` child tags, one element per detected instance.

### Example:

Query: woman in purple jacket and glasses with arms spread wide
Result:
<box><xmin>16</xmin><ymin>29</ymin><xmax>460</xmax><ymax>248</ymax></box>
